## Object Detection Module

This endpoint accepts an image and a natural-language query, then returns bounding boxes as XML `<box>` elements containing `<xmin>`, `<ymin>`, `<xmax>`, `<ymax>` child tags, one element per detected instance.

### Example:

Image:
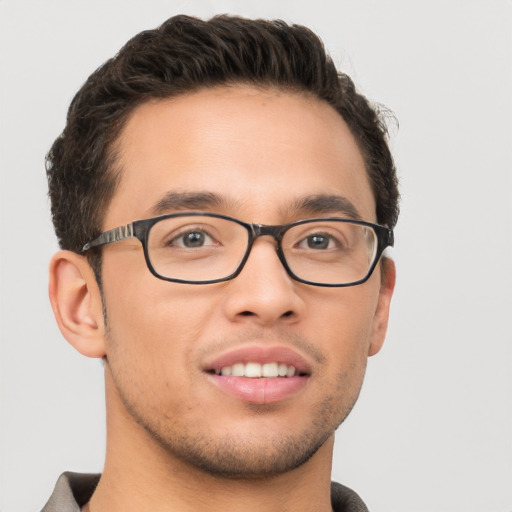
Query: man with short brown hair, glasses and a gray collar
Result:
<box><xmin>43</xmin><ymin>16</ymin><xmax>398</xmax><ymax>512</ymax></box>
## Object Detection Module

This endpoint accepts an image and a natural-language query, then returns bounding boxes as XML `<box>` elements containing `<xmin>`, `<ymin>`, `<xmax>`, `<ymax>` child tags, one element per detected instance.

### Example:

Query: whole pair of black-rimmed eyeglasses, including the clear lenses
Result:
<box><xmin>82</xmin><ymin>212</ymin><xmax>393</xmax><ymax>287</ymax></box>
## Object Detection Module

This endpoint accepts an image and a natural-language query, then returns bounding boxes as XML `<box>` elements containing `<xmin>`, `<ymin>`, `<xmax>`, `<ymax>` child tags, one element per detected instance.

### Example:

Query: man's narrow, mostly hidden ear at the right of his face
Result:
<box><xmin>368</xmin><ymin>258</ymin><xmax>396</xmax><ymax>356</ymax></box>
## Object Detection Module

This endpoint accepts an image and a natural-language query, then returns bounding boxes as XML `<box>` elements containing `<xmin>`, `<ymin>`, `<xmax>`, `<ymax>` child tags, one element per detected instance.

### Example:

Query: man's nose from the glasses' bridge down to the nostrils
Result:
<box><xmin>223</xmin><ymin>236</ymin><xmax>304</xmax><ymax>326</ymax></box>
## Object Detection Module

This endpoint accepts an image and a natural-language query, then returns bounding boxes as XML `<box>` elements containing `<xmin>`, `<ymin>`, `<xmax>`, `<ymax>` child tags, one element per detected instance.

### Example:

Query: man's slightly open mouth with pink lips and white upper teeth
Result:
<box><xmin>204</xmin><ymin>347</ymin><xmax>311</xmax><ymax>404</ymax></box>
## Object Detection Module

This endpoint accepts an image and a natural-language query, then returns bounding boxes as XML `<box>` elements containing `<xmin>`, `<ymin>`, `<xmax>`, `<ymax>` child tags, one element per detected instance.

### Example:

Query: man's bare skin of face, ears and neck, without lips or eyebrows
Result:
<box><xmin>50</xmin><ymin>86</ymin><xmax>394</xmax><ymax>512</ymax></box>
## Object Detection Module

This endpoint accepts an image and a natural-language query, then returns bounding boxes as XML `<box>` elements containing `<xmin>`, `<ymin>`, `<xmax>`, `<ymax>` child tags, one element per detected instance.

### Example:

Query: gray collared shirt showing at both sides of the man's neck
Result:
<box><xmin>41</xmin><ymin>472</ymin><xmax>368</xmax><ymax>512</ymax></box>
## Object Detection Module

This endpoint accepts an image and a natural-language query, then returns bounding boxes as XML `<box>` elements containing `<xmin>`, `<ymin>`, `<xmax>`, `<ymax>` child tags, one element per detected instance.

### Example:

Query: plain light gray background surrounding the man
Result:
<box><xmin>0</xmin><ymin>0</ymin><xmax>512</xmax><ymax>512</ymax></box>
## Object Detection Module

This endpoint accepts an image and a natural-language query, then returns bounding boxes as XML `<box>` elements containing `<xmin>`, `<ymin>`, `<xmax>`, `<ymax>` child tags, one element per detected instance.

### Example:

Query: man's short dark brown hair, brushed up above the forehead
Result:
<box><xmin>46</xmin><ymin>15</ymin><xmax>399</xmax><ymax>268</ymax></box>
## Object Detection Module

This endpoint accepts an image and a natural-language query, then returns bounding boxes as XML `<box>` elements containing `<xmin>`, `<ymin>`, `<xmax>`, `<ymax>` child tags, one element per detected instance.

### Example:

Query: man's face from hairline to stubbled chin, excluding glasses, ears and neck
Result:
<box><xmin>97</xmin><ymin>86</ymin><xmax>389</xmax><ymax>477</ymax></box>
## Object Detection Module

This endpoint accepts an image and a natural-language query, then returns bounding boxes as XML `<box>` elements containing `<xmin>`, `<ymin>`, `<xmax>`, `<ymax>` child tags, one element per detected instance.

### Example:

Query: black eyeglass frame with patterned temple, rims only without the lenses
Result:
<box><xmin>82</xmin><ymin>212</ymin><xmax>394</xmax><ymax>288</ymax></box>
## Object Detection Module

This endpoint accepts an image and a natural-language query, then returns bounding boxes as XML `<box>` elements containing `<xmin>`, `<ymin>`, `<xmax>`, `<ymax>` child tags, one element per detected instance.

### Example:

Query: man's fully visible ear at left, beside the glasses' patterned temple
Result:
<box><xmin>49</xmin><ymin>251</ymin><xmax>105</xmax><ymax>357</ymax></box>
